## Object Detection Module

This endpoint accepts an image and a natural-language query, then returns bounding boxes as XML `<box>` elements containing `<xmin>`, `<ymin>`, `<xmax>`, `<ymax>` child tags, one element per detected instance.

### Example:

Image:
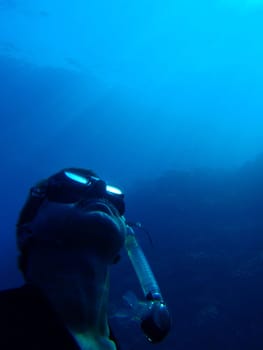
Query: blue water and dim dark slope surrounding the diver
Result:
<box><xmin>0</xmin><ymin>0</ymin><xmax>263</xmax><ymax>350</ymax></box>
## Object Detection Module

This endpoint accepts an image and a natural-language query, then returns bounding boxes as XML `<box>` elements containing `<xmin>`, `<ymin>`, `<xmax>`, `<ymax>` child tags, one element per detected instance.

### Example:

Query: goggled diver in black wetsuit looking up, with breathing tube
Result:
<box><xmin>0</xmin><ymin>168</ymin><xmax>170</xmax><ymax>350</ymax></box>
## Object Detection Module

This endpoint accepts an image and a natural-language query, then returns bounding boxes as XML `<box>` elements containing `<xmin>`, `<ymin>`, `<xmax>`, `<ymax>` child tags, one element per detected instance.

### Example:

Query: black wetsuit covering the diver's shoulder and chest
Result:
<box><xmin>0</xmin><ymin>285</ymin><xmax>120</xmax><ymax>350</ymax></box>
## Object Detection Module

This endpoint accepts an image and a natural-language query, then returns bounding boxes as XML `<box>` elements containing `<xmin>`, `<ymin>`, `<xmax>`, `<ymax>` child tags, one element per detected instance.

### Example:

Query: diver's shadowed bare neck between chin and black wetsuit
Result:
<box><xmin>26</xmin><ymin>254</ymin><xmax>115</xmax><ymax>349</ymax></box>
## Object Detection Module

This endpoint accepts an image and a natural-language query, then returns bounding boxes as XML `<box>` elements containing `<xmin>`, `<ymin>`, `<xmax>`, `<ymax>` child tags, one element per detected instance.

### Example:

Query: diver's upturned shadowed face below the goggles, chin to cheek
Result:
<box><xmin>30</xmin><ymin>198</ymin><xmax>126</xmax><ymax>263</ymax></box>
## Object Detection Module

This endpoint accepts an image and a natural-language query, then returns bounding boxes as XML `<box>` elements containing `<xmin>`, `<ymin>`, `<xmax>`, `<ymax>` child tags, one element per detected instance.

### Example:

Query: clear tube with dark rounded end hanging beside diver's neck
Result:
<box><xmin>125</xmin><ymin>223</ymin><xmax>171</xmax><ymax>343</ymax></box>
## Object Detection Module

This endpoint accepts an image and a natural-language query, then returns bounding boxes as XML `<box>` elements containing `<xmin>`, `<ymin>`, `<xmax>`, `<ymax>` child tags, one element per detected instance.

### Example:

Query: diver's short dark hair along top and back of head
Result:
<box><xmin>16</xmin><ymin>168</ymin><xmax>98</xmax><ymax>277</ymax></box>
